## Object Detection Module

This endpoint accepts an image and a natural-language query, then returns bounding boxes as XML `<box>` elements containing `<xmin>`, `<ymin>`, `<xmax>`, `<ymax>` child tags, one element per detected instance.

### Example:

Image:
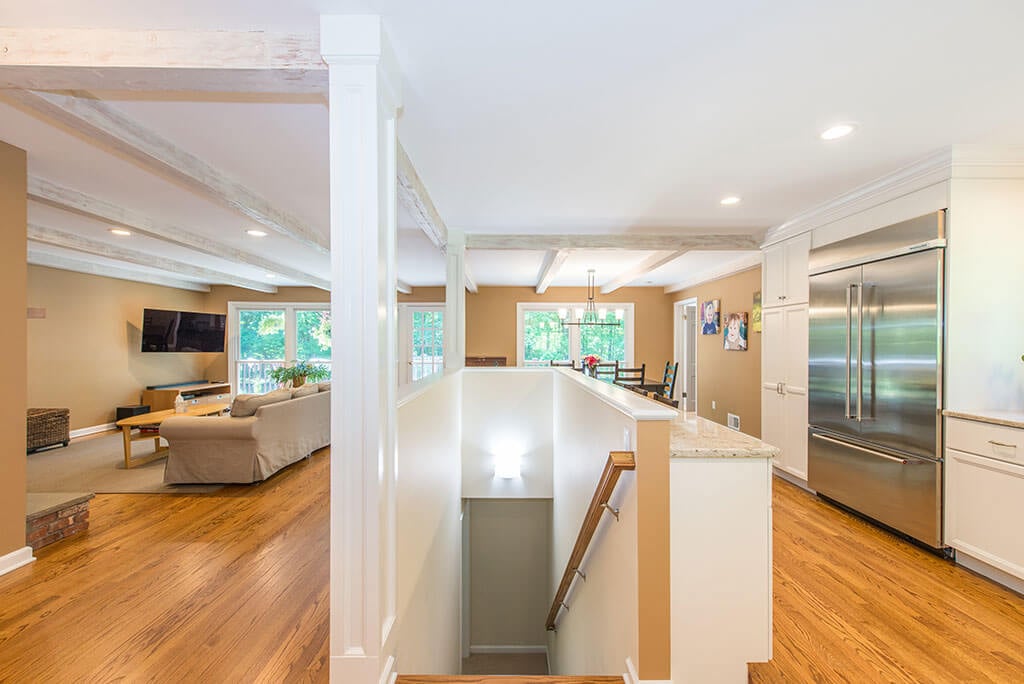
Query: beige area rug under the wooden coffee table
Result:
<box><xmin>26</xmin><ymin>432</ymin><xmax>222</xmax><ymax>494</ymax></box>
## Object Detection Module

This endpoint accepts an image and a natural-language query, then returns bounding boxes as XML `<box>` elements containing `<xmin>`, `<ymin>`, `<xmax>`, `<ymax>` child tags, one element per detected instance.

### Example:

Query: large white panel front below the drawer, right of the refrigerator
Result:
<box><xmin>945</xmin><ymin>448</ymin><xmax>1024</xmax><ymax>579</ymax></box>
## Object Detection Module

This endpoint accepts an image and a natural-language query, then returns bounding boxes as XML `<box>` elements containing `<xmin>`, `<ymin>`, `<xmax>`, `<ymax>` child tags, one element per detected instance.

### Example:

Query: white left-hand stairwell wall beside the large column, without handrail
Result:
<box><xmin>382</xmin><ymin>373</ymin><xmax>462</xmax><ymax>675</ymax></box>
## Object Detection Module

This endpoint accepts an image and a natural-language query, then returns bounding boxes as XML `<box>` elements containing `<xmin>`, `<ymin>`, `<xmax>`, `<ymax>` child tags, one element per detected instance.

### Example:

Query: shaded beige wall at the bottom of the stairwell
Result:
<box><xmin>469</xmin><ymin>499</ymin><xmax>551</xmax><ymax>646</ymax></box>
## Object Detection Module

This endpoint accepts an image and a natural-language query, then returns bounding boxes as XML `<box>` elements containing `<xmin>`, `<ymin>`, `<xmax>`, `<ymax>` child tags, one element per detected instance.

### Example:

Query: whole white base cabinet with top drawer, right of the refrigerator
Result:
<box><xmin>944</xmin><ymin>418</ymin><xmax>1024</xmax><ymax>580</ymax></box>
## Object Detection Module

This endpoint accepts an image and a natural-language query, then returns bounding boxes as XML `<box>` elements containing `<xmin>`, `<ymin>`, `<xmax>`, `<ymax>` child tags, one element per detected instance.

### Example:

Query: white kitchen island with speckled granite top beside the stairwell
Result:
<box><xmin>669</xmin><ymin>414</ymin><xmax>778</xmax><ymax>682</ymax></box>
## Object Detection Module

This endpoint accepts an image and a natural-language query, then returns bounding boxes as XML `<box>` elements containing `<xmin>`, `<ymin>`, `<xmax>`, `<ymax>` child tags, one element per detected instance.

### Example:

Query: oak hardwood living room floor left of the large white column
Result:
<box><xmin>0</xmin><ymin>450</ymin><xmax>330</xmax><ymax>682</ymax></box>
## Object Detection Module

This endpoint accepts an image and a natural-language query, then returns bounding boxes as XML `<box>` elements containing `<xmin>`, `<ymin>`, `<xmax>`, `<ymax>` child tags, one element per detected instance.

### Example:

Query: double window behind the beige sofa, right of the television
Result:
<box><xmin>227</xmin><ymin>302</ymin><xmax>331</xmax><ymax>394</ymax></box>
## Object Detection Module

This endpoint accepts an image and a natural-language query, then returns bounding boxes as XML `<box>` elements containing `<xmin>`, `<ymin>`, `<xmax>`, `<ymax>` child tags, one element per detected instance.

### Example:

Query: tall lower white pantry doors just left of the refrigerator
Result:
<box><xmin>761</xmin><ymin>304</ymin><xmax>807</xmax><ymax>481</ymax></box>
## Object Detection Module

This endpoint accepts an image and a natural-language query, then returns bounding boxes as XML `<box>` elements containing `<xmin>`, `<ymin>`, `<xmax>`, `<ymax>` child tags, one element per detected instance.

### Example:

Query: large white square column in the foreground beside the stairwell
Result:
<box><xmin>321</xmin><ymin>15</ymin><xmax>400</xmax><ymax>684</ymax></box>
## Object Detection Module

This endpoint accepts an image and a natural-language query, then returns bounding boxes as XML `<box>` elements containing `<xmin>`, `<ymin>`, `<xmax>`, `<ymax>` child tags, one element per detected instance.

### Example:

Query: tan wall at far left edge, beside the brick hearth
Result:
<box><xmin>0</xmin><ymin>142</ymin><xmax>29</xmax><ymax>556</ymax></box>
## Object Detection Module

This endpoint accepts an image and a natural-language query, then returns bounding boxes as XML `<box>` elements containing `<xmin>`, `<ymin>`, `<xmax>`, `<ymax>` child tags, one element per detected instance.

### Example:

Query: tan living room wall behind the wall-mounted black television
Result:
<box><xmin>28</xmin><ymin>266</ymin><xmax>209</xmax><ymax>429</ymax></box>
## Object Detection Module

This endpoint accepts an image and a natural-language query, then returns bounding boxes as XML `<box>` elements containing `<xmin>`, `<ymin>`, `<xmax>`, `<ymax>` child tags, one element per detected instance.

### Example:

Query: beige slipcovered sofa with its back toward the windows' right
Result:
<box><xmin>160</xmin><ymin>383</ymin><xmax>331</xmax><ymax>484</ymax></box>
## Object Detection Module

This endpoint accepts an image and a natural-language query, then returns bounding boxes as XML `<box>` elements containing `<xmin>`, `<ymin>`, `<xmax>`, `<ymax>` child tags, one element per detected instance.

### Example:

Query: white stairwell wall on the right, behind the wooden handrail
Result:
<box><xmin>548</xmin><ymin>371</ymin><xmax>639</xmax><ymax>675</ymax></box>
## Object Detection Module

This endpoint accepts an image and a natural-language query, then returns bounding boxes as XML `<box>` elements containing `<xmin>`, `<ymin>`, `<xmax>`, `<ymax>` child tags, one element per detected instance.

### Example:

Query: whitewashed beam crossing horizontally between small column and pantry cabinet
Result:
<box><xmin>466</xmin><ymin>232</ymin><xmax>761</xmax><ymax>252</ymax></box>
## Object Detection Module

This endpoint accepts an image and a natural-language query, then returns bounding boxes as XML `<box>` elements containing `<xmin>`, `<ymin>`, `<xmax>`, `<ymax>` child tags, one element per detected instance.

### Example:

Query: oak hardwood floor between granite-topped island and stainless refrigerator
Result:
<box><xmin>750</xmin><ymin>477</ymin><xmax>1024</xmax><ymax>684</ymax></box>
